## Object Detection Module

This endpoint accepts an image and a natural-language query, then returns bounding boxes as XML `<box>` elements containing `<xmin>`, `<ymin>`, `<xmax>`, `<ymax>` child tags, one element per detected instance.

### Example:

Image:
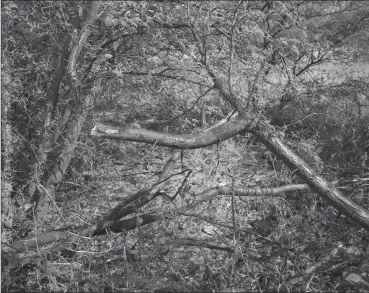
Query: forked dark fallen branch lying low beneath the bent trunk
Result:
<box><xmin>0</xmin><ymin>181</ymin><xmax>314</xmax><ymax>252</ymax></box>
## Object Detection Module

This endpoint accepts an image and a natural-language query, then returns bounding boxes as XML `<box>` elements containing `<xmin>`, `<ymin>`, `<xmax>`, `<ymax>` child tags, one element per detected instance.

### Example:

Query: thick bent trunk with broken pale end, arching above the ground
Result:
<box><xmin>91</xmin><ymin>115</ymin><xmax>369</xmax><ymax>230</ymax></box>
